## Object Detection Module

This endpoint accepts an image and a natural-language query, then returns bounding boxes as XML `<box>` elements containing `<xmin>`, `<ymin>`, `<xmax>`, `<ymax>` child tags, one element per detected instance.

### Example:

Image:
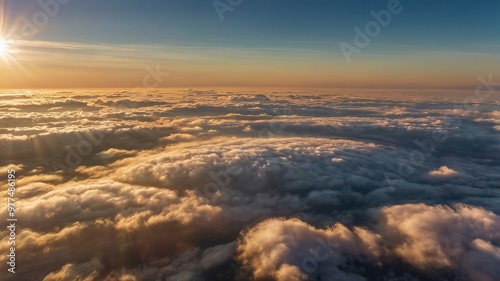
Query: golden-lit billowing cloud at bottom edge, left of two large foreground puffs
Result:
<box><xmin>238</xmin><ymin>219</ymin><xmax>376</xmax><ymax>280</ymax></box>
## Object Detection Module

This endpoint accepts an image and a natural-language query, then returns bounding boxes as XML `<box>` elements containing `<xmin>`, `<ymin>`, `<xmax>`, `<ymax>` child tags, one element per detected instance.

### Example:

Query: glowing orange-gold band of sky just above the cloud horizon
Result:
<box><xmin>0</xmin><ymin>1</ymin><xmax>500</xmax><ymax>89</ymax></box>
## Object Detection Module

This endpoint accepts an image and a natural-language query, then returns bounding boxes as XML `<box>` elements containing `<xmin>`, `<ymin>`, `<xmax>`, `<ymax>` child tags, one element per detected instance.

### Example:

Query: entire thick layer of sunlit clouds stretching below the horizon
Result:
<box><xmin>0</xmin><ymin>90</ymin><xmax>500</xmax><ymax>281</ymax></box>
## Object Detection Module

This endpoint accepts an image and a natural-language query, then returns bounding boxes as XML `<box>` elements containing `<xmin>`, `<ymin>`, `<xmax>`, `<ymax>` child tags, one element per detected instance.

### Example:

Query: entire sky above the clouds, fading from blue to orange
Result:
<box><xmin>0</xmin><ymin>0</ymin><xmax>500</xmax><ymax>88</ymax></box>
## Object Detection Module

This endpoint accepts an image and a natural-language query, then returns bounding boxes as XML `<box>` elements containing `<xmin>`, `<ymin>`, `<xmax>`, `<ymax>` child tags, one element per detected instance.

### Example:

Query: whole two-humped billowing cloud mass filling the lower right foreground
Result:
<box><xmin>238</xmin><ymin>204</ymin><xmax>500</xmax><ymax>280</ymax></box>
